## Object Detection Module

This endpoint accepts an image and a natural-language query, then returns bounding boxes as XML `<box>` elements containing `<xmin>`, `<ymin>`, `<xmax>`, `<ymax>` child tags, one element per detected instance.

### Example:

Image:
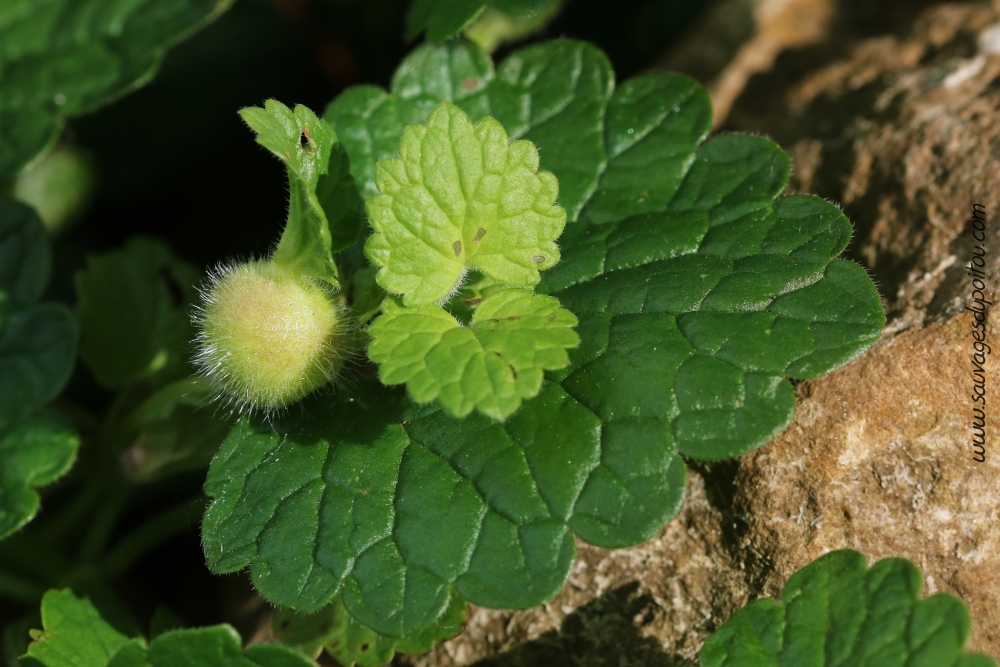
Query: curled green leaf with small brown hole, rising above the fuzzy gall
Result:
<box><xmin>240</xmin><ymin>100</ymin><xmax>361</xmax><ymax>286</ymax></box>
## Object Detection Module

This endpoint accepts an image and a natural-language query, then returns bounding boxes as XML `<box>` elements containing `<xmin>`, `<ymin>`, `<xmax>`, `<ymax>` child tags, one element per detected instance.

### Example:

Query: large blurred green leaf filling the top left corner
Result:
<box><xmin>0</xmin><ymin>0</ymin><xmax>232</xmax><ymax>182</ymax></box>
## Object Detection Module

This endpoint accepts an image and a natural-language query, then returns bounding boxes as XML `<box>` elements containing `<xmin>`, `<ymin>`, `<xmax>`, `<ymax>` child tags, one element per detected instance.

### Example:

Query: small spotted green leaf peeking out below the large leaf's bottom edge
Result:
<box><xmin>272</xmin><ymin>597</ymin><xmax>466</xmax><ymax>667</ymax></box>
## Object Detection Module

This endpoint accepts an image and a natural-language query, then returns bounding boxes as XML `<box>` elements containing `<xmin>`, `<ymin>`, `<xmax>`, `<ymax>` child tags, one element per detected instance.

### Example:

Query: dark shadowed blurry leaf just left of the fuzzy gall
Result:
<box><xmin>76</xmin><ymin>237</ymin><xmax>201</xmax><ymax>389</ymax></box>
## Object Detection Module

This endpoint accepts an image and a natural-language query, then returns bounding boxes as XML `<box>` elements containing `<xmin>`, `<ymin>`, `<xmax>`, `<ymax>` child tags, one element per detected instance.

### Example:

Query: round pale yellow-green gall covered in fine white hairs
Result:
<box><xmin>198</xmin><ymin>261</ymin><xmax>345</xmax><ymax>411</ymax></box>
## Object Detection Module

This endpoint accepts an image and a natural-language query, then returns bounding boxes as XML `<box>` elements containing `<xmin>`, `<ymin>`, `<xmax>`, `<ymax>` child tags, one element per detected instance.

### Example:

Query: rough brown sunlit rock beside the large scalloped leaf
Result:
<box><xmin>397</xmin><ymin>0</ymin><xmax>1000</xmax><ymax>667</ymax></box>
